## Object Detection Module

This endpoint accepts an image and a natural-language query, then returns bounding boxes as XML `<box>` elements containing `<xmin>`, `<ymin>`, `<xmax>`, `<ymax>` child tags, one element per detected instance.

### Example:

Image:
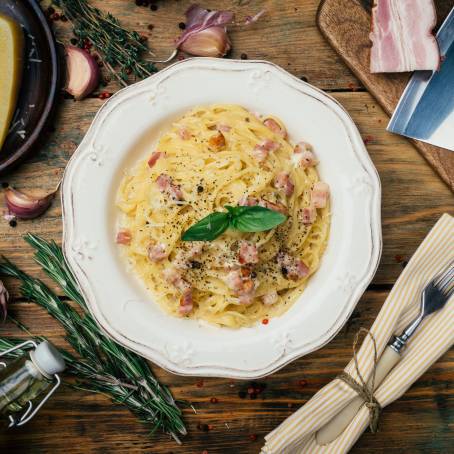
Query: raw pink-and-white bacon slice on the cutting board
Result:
<box><xmin>370</xmin><ymin>0</ymin><xmax>440</xmax><ymax>73</ymax></box>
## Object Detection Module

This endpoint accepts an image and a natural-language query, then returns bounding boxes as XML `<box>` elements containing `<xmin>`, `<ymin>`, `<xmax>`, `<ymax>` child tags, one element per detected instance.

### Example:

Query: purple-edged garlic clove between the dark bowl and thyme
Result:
<box><xmin>65</xmin><ymin>46</ymin><xmax>100</xmax><ymax>99</ymax></box>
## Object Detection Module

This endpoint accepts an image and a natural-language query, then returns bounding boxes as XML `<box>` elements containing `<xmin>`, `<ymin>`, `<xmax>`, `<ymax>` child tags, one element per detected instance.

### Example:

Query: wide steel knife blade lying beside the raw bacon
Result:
<box><xmin>387</xmin><ymin>8</ymin><xmax>454</xmax><ymax>151</ymax></box>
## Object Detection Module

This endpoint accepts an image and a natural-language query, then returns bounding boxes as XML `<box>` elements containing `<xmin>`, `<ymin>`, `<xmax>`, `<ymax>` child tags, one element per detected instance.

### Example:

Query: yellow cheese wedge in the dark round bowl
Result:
<box><xmin>0</xmin><ymin>14</ymin><xmax>24</xmax><ymax>150</ymax></box>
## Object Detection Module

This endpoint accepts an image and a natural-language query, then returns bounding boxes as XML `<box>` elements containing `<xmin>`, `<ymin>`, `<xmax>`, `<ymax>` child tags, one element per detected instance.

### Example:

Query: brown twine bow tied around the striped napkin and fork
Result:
<box><xmin>337</xmin><ymin>328</ymin><xmax>381</xmax><ymax>433</ymax></box>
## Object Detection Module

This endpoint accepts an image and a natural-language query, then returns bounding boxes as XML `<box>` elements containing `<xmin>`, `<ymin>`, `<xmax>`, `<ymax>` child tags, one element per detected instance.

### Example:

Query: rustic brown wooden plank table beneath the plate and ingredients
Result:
<box><xmin>0</xmin><ymin>0</ymin><xmax>454</xmax><ymax>454</ymax></box>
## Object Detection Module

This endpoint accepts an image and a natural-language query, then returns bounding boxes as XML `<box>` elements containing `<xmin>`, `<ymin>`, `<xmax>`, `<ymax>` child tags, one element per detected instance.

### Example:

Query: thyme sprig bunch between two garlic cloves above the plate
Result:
<box><xmin>53</xmin><ymin>0</ymin><xmax>157</xmax><ymax>86</ymax></box>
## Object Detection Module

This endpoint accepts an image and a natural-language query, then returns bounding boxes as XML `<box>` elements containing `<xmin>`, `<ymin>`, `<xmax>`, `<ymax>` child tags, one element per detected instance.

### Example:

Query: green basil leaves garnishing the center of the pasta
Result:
<box><xmin>181</xmin><ymin>205</ymin><xmax>287</xmax><ymax>241</ymax></box>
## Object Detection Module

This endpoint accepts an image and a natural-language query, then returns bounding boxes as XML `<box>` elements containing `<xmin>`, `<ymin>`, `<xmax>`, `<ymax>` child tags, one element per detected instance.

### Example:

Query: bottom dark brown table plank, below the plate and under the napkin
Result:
<box><xmin>0</xmin><ymin>291</ymin><xmax>454</xmax><ymax>454</ymax></box>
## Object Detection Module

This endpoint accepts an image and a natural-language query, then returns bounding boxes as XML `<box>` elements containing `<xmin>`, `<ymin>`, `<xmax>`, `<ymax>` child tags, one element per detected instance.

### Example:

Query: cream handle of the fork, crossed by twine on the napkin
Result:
<box><xmin>315</xmin><ymin>346</ymin><xmax>401</xmax><ymax>445</ymax></box>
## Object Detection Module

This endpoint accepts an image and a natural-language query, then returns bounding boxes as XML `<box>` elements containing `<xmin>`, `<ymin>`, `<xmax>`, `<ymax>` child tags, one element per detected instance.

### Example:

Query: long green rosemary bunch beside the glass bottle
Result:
<box><xmin>0</xmin><ymin>234</ymin><xmax>186</xmax><ymax>443</ymax></box>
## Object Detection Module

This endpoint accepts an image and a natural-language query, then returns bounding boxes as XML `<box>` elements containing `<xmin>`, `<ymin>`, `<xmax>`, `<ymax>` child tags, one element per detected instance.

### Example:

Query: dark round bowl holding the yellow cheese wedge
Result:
<box><xmin>0</xmin><ymin>0</ymin><xmax>59</xmax><ymax>174</ymax></box>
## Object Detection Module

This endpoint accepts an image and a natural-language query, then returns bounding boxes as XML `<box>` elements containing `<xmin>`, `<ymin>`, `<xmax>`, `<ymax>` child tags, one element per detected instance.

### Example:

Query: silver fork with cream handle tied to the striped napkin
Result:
<box><xmin>316</xmin><ymin>260</ymin><xmax>454</xmax><ymax>445</ymax></box>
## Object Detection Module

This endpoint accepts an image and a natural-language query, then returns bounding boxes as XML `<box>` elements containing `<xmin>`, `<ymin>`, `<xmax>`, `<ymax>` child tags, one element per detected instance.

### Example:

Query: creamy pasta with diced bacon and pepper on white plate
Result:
<box><xmin>117</xmin><ymin>105</ymin><xmax>330</xmax><ymax>328</ymax></box>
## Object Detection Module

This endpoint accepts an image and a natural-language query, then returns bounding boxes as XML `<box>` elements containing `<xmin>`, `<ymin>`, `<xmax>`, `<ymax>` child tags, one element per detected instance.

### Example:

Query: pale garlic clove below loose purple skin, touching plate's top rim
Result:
<box><xmin>179</xmin><ymin>27</ymin><xmax>231</xmax><ymax>57</ymax></box>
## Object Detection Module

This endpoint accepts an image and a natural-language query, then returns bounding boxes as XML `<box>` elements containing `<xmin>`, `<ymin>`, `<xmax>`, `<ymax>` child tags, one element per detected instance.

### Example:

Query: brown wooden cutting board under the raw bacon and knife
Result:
<box><xmin>317</xmin><ymin>0</ymin><xmax>454</xmax><ymax>191</ymax></box>
